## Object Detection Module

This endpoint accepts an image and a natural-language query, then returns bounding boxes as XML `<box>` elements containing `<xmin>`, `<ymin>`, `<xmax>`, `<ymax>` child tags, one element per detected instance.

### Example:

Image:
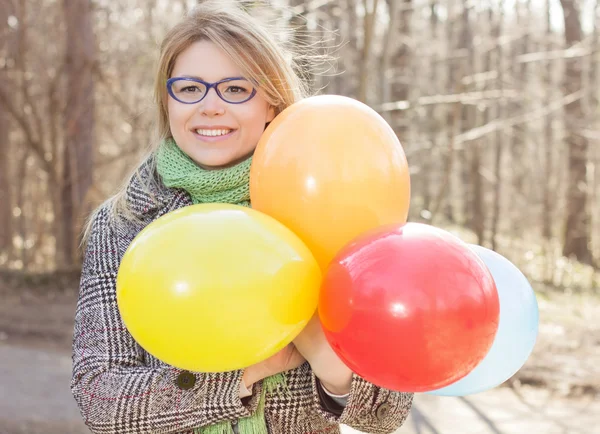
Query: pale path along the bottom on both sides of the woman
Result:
<box><xmin>0</xmin><ymin>344</ymin><xmax>600</xmax><ymax>434</ymax></box>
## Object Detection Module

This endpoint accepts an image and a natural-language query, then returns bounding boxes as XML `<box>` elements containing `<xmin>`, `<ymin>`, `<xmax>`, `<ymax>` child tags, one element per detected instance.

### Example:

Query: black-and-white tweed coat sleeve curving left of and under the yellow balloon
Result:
<box><xmin>71</xmin><ymin>208</ymin><xmax>260</xmax><ymax>434</ymax></box>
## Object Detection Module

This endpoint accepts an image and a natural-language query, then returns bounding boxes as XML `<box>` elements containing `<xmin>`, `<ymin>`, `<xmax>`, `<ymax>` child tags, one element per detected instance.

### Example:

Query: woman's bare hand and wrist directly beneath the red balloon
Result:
<box><xmin>294</xmin><ymin>314</ymin><xmax>353</xmax><ymax>395</ymax></box>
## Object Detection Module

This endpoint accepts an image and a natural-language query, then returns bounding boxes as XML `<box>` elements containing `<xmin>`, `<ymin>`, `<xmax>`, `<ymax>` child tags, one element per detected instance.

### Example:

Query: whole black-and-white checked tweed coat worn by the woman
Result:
<box><xmin>71</xmin><ymin>163</ymin><xmax>413</xmax><ymax>434</ymax></box>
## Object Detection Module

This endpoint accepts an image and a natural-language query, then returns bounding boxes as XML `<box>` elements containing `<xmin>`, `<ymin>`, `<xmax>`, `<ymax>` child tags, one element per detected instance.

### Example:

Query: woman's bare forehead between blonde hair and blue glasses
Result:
<box><xmin>171</xmin><ymin>41</ymin><xmax>243</xmax><ymax>81</ymax></box>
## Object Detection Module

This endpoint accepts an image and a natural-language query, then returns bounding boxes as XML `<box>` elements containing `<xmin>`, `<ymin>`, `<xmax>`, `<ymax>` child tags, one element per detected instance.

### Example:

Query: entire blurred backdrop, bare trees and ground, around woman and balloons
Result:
<box><xmin>0</xmin><ymin>0</ymin><xmax>600</xmax><ymax>434</ymax></box>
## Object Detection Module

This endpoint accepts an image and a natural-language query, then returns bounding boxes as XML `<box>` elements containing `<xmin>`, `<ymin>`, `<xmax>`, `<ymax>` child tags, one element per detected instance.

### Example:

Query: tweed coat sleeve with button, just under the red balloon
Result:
<box><xmin>312</xmin><ymin>374</ymin><xmax>414</xmax><ymax>434</ymax></box>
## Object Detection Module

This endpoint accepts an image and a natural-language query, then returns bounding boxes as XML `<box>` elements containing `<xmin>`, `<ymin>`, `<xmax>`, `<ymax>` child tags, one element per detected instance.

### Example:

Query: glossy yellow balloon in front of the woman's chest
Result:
<box><xmin>117</xmin><ymin>204</ymin><xmax>321</xmax><ymax>372</ymax></box>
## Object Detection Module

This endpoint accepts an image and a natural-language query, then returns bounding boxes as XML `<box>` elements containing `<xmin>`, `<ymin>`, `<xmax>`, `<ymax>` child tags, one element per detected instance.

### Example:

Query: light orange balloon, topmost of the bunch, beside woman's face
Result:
<box><xmin>250</xmin><ymin>95</ymin><xmax>410</xmax><ymax>270</ymax></box>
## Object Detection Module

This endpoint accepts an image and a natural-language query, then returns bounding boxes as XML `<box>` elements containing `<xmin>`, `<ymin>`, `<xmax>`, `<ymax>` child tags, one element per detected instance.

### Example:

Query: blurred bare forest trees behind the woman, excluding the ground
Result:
<box><xmin>0</xmin><ymin>0</ymin><xmax>600</xmax><ymax>288</ymax></box>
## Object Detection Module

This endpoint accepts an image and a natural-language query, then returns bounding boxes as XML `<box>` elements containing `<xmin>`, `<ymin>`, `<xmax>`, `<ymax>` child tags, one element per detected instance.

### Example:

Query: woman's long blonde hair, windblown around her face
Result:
<box><xmin>82</xmin><ymin>0</ymin><xmax>316</xmax><ymax>243</ymax></box>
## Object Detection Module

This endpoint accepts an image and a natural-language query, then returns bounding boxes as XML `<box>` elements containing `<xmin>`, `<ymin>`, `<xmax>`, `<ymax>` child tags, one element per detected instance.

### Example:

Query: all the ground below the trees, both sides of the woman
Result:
<box><xmin>0</xmin><ymin>273</ymin><xmax>600</xmax><ymax>434</ymax></box>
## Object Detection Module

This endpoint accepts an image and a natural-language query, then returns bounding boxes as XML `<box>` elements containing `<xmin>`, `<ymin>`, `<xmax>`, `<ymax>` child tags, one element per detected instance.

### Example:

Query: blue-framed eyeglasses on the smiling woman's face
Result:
<box><xmin>167</xmin><ymin>77</ymin><xmax>256</xmax><ymax>104</ymax></box>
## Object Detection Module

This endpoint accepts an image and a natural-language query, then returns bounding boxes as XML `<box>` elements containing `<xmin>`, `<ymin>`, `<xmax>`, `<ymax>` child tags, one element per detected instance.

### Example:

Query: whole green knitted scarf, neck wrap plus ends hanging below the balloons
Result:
<box><xmin>156</xmin><ymin>139</ymin><xmax>287</xmax><ymax>434</ymax></box>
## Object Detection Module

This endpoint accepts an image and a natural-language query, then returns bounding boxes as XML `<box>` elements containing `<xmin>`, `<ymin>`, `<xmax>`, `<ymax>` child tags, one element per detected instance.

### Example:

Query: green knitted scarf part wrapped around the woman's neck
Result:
<box><xmin>156</xmin><ymin>139</ymin><xmax>252</xmax><ymax>206</ymax></box>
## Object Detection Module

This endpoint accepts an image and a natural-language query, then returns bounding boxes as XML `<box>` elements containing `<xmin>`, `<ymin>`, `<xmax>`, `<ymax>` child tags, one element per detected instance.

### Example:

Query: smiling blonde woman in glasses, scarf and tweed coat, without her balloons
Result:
<box><xmin>72</xmin><ymin>2</ymin><xmax>412</xmax><ymax>434</ymax></box>
